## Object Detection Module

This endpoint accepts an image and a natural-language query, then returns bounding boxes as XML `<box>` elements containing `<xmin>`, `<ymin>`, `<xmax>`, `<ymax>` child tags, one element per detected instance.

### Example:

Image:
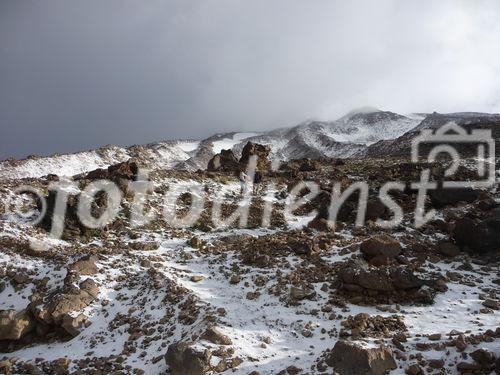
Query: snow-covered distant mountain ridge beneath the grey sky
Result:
<box><xmin>0</xmin><ymin>107</ymin><xmax>500</xmax><ymax>178</ymax></box>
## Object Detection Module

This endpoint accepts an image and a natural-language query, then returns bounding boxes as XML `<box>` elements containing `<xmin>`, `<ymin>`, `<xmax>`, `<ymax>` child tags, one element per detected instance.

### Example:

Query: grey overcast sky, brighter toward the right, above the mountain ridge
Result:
<box><xmin>0</xmin><ymin>0</ymin><xmax>500</xmax><ymax>159</ymax></box>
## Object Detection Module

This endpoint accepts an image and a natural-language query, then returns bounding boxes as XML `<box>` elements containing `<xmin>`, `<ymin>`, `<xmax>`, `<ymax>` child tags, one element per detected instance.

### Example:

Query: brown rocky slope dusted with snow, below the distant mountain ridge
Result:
<box><xmin>0</xmin><ymin>153</ymin><xmax>500</xmax><ymax>375</ymax></box>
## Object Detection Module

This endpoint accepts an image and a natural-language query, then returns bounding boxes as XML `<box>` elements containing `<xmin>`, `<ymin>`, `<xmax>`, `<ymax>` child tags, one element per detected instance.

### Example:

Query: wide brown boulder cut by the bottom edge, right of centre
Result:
<box><xmin>326</xmin><ymin>340</ymin><xmax>397</xmax><ymax>375</ymax></box>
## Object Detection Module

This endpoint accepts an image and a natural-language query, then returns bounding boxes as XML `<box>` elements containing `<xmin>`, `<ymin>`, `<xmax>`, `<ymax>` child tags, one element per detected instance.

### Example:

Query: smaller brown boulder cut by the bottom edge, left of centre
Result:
<box><xmin>165</xmin><ymin>342</ymin><xmax>212</xmax><ymax>375</ymax></box>
